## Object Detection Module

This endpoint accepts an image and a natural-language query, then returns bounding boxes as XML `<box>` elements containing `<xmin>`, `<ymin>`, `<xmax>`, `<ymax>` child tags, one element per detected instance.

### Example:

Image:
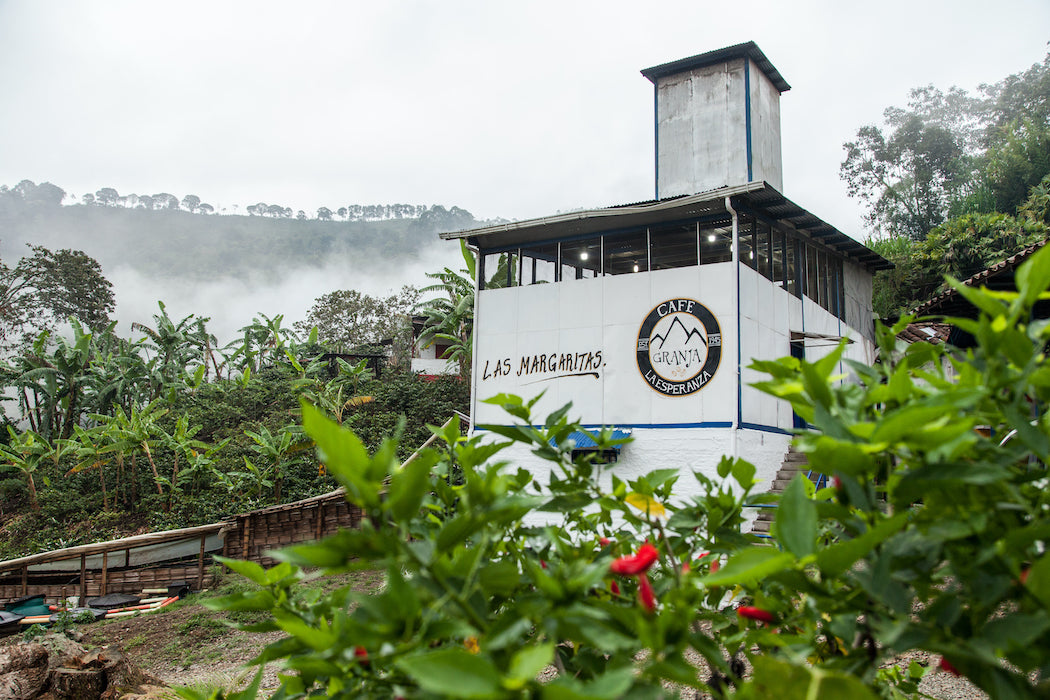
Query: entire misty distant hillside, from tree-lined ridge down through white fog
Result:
<box><xmin>0</xmin><ymin>181</ymin><xmax>483</xmax><ymax>342</ymax></box>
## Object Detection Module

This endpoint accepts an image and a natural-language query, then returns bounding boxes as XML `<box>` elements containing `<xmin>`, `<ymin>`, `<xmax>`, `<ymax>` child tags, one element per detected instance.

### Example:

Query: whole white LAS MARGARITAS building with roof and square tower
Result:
<box><xmin>442</xmin><ymin>42</ymin><xmax>890</xmax><ymax>489</ymax></box>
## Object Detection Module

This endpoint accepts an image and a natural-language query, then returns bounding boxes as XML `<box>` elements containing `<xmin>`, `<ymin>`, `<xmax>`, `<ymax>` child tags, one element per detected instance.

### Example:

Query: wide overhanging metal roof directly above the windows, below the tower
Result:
<box><xmin>440</xmin><ymin>183</ymin><xmax>894</xmax><ymax>271</ymax></box>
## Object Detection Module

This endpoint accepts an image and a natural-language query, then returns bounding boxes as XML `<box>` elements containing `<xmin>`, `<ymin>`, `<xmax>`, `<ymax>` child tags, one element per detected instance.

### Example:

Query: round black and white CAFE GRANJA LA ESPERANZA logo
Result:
<box><xmin>637</xmin><ymin>299</ymin><xmax>721</xmax><ymax>396</ymax></box>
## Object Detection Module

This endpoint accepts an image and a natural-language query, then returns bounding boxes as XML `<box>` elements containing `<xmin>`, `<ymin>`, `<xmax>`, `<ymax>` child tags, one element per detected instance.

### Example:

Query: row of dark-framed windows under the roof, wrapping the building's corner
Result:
<box><xmin>479</xmin><ymin>214</ymin><xmax>845</xmax><ymax>319</ymax></box>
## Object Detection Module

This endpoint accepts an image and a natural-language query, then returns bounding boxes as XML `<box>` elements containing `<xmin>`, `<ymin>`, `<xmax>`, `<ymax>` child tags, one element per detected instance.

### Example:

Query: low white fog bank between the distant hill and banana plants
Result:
<box><xmin>103</xmin><ymin>240</ymin><xmax>463</xmax><ymax>344</ymax></box>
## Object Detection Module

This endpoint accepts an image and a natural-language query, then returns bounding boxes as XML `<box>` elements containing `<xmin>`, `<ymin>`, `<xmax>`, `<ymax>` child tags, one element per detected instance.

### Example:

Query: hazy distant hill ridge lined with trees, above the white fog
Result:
<box><xmin>0</xmin><ymin>181</ymin><xmax>479</xmax><ymax>280</ymax></box>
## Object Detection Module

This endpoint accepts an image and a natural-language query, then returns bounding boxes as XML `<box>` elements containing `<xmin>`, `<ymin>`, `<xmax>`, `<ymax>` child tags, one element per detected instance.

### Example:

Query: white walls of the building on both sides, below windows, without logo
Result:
<box><xmin>473</xmin><ymin>251</ymin><xmax>874</xmax><ymax>510</ymax></box>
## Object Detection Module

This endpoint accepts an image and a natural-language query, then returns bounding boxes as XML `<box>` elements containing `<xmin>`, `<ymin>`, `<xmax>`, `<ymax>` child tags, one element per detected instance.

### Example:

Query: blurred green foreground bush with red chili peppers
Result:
<box><xmin>200</xmin><ymin>249</ymin><xmax>1050</xmax><ymax>699</ymax></box>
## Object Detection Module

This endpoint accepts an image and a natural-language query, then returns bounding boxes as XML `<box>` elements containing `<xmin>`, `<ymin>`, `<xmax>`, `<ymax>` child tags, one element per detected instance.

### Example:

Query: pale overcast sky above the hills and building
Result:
<box><xmin>0</xmin><ymin>0</ymin><xmax>1050</xmax><ymax>238</ymax></box>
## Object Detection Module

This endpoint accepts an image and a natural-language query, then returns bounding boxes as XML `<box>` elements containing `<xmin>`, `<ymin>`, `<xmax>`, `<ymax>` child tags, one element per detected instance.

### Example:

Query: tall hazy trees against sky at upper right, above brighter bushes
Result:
<box><xmin>840</xmin><ymin>50</ymin><xmax>1050</xmax><ymax>240</ymax></box>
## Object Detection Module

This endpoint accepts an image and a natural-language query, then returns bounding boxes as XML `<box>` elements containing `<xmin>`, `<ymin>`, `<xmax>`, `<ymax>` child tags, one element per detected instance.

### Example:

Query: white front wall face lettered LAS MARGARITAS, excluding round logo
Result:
<box><xmin>473</xmin><ymin>263</ymin><xmax>736</xmax><ymax>426</ymax></box>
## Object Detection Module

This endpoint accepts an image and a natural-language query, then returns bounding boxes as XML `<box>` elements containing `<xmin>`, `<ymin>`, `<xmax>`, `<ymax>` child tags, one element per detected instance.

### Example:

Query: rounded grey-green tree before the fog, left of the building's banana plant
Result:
<box><xmin>294</xmin><ymin>285</ymin><xmax>420</xmax><ymax>348</ymax></box>
